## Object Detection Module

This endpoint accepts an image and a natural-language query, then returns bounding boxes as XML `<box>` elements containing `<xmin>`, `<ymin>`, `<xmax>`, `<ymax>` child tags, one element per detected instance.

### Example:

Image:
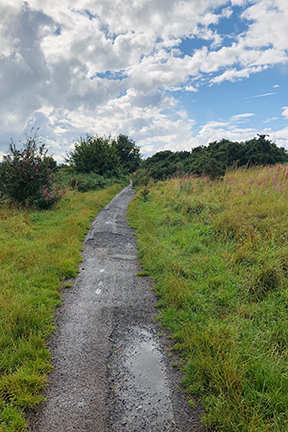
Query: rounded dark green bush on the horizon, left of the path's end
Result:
<box><xmin>66</xmin><ymin>135</ymin><xmax>140</xmax><ymax>177</ymax></box>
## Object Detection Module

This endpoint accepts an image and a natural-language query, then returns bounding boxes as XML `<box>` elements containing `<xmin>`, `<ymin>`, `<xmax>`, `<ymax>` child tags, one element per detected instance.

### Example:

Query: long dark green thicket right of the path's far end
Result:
<box><xmin>134</xmin><ymin>135</ymin><xmax>288</xmax><ymax>185</ymax></box>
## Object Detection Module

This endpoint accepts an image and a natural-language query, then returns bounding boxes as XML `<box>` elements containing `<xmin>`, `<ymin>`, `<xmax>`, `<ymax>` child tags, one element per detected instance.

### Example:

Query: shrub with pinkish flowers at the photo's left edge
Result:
<box><xmin>0</xmin><ymin>135</ymin><xmax>66</xmax><ymax>209</ymax></box>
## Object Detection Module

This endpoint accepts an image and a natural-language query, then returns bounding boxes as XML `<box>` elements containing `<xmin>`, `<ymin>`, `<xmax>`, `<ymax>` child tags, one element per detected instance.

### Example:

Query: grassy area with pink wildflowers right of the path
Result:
<box><xmin>128</xmin><ymin>166</ymin><xmax>288</xmax><ymax>432</ymax></box>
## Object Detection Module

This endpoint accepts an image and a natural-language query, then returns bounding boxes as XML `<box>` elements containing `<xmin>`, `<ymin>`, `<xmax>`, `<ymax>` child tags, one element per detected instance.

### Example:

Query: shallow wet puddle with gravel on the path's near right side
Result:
<box><xmin>109</xmin><ymin>327</ymin><xmax>174</xmax><ymax>432</ymax></box>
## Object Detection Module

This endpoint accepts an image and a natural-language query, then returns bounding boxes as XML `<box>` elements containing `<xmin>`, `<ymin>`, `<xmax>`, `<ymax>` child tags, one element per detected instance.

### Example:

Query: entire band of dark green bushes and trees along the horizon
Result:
<box><xmin>0</xmin><ymin>130</ymin><xmax>288</xmax><ymax>209</ymax></box>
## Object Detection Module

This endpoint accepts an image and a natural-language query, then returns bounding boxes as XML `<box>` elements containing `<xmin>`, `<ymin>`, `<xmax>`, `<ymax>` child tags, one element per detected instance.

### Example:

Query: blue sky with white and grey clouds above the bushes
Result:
<box><xmin>0</xmin><ymin>0</ymin><xmax>288</xmax><ymax>163</ymax></box>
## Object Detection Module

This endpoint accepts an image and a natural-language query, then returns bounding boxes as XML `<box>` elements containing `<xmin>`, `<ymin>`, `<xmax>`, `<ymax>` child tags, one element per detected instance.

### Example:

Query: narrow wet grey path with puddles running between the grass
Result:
<box><xmin>29</xmin><ymin>186</ymin><xmax>202</xmax><ymax>432</ymax></box>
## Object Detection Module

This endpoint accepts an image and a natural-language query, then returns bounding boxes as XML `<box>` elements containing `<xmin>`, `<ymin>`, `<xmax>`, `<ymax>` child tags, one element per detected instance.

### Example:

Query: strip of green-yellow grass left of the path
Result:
<box><xmin>0</xmin><ymin>184</ymin><xmax>123</xmax><ymax>432</ymax></box>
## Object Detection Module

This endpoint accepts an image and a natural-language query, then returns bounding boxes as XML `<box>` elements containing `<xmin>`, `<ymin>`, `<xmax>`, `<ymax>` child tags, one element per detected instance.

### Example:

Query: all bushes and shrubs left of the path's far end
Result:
<box><xmin>0</xmin><ymin>130</ymin><xmax>141</xmax><ymax>210</ymax></box>
